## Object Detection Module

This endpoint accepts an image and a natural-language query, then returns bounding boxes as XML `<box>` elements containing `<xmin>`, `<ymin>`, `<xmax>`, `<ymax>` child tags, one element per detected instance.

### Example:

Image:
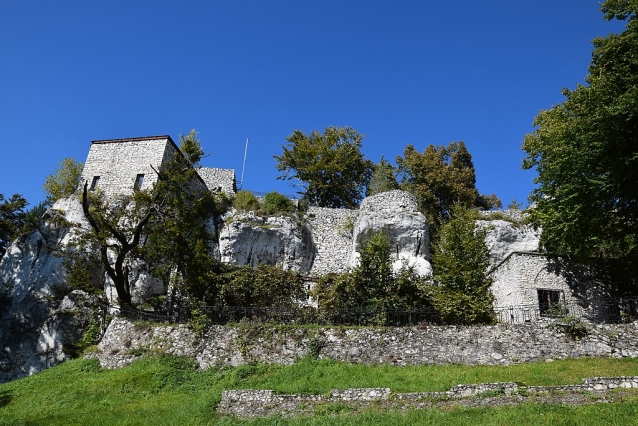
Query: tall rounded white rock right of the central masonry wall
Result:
<box><xmin>350</xmin><ymin>190</ymin><xmax>432</xmax><ymax>275</ymax></box>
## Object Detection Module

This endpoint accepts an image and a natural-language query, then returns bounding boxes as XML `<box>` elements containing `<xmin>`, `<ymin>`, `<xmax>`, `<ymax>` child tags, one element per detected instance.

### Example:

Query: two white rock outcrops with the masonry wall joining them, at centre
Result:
<box><xmin>219</xmin><ymin>191</ymin><xmax>432</xmax><ymax>276</ymax></box>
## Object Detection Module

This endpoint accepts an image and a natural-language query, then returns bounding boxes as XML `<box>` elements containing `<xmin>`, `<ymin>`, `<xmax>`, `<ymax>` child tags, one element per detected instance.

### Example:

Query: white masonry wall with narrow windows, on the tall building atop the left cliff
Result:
<box><xmin>82</xmin><ymin>136</ymin><xmax>176</xmax><ymax>196</ymax></box>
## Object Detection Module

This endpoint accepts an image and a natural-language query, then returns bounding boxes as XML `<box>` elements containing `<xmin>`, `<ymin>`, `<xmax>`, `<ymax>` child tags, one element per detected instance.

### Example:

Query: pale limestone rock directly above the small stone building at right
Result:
<box><xmin>476</xmin><ymin>220</ymin><xmax>541</xmax><ymax>265</ymax></box>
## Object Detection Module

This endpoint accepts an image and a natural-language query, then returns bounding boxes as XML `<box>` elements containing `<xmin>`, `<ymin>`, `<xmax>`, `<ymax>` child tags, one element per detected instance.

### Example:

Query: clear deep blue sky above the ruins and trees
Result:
<box><xmin>0</xmin><ymin>0</ymin><xmax>624</xmax><ymax>209</ymax></box>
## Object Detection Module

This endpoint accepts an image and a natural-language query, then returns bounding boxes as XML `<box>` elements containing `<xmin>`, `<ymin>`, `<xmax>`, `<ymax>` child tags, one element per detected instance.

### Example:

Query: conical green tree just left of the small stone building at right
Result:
<box><xmin>432</xmin><ymin>205</ymin><xmax>494</xmax><ymax>324</ymax></box>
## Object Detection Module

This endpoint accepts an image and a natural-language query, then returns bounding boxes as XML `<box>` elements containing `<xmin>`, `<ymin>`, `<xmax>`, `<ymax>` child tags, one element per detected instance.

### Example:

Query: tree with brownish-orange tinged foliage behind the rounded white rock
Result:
<box><xmin>396</xmin><ymin>141</ymin><xmax>501</xmax><ymax>240</ymax></box>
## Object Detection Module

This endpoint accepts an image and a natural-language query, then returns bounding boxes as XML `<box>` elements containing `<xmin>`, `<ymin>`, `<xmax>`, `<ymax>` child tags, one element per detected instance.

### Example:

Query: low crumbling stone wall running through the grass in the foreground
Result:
<box><xmin>217</xmin><ymin>376</ymin><xmax>638</xmax><ymax>418</ymax></box>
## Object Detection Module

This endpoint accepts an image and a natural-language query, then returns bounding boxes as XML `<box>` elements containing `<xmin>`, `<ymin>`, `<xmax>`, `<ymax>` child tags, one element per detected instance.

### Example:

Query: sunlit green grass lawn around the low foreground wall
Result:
<box><xmin>0</xmin><ymin>357</ymin><xmax>638</xmax><ymax>426</ymax></box>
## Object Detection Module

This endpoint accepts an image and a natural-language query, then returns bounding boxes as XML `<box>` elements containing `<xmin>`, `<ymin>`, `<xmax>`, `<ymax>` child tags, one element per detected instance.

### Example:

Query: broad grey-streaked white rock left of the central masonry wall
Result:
<box><xmin>219</xmin><ymin>212</ymin><xmax>314</xmax><ymax>273</ymax></box>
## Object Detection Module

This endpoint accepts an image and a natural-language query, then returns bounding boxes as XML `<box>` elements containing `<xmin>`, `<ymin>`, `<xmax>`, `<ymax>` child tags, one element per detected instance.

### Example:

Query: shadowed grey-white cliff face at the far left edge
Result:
<box><xmin>0</xmin><ymin>200</ymin><xmax>98</xmax><ymax>382</ymax></box>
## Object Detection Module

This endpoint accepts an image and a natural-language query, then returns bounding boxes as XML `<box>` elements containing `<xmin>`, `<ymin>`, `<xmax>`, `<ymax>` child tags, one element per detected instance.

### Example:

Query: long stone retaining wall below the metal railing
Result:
<box><xmin>94</xmin><ymin>317</ymin><xmax>638</xmax><ymax>369</ymax></box>
